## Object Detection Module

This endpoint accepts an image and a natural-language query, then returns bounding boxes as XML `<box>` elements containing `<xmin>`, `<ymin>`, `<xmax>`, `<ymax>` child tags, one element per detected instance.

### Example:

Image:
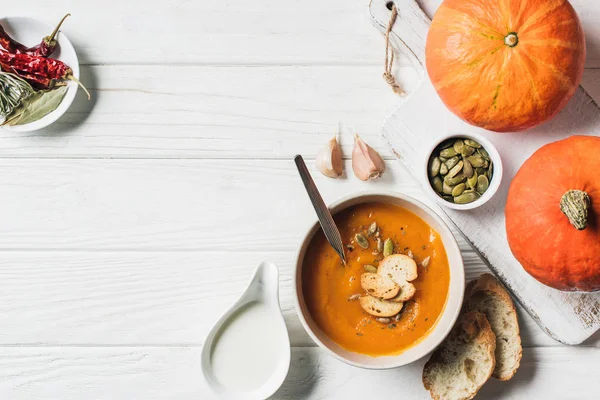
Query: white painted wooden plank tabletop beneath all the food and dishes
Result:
<box><xmin>0</xmin><ymin>0</ymin><xmax>600</xmax><ymax>400</ymax></box>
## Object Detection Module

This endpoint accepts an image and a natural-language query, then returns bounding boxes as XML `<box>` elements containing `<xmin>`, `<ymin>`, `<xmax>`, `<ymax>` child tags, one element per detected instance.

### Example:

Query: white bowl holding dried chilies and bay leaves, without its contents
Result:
<box><xmin>0</xmin><ymin>17</ymin><xmax>79</xmax><ymax>132</ymax></box>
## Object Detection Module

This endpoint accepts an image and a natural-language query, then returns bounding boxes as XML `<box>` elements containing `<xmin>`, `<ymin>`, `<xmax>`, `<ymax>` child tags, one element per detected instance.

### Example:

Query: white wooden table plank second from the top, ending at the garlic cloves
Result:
<box><xmin>0</xmin><ymin>66</ymin><xmax>416</xmax><ymax>159</ymax></box>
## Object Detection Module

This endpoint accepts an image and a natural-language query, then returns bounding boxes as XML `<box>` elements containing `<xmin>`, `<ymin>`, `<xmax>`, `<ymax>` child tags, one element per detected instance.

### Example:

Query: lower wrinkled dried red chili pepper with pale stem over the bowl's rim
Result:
<box><xmin>0</xmin><ymin>51</ymin><xmax>91</xmax><ymax>99</ymax></box>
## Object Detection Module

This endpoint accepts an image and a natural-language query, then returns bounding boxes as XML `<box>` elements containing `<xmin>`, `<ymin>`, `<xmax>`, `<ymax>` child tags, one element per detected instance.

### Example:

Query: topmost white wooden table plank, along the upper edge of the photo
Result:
<box><xmin>8</xmin><ymin>0</ymin><xmax>600</xmax><ymax>67</ymax></box>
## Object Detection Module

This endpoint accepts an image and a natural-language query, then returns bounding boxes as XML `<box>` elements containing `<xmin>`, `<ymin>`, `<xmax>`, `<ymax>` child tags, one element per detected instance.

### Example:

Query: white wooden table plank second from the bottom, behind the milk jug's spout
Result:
<box><xmin>0</xmin><ymin>247</ymin><xmax>588</xmax><ymax>347</ymax></box>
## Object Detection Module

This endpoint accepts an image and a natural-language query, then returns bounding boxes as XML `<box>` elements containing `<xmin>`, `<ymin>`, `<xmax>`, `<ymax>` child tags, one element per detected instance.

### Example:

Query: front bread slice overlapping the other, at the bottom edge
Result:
<box><xmin>423</xmin><ymin>312</ymin><xmax>496</xmax><ymax>400</ymax></box>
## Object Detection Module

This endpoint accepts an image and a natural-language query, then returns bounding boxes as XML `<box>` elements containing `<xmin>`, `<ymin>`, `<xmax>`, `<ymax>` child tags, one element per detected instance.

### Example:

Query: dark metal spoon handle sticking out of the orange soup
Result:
<box><xmin>294</xmin><ymin>154</ymin><xmax>346</xmax><ymax>264</ymax></box>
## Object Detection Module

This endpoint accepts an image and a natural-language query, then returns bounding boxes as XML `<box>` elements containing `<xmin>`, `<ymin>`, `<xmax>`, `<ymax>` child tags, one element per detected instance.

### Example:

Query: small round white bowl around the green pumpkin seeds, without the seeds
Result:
<box><xmin>422</xmin><ymin>133</ymin><xmax>503</xmax><ymax>210</ymax></box>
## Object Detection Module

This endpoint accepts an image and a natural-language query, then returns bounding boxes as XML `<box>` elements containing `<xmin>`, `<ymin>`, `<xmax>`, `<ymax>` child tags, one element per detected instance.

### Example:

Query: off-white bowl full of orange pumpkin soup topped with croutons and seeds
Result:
<box><xmin>293</xmin><ymin>192</ymin><xmax>465</xmax><ymax>369</ymax></box>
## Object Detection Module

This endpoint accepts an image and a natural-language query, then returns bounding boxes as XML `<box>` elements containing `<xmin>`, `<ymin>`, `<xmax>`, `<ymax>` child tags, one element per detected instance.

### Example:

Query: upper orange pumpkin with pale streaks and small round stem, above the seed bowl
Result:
<box><xmin>426</xmin><ymin>0</ymin><xmax>585</xmax><ymax>132</ymax></box>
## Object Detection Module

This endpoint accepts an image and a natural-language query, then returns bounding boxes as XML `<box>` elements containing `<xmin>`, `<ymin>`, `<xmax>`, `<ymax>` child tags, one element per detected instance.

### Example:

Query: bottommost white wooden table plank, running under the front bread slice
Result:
<box><xmin>0</xmin><ymin>347</ymin><xmax>600</xmax><ymax>400</ymax></box>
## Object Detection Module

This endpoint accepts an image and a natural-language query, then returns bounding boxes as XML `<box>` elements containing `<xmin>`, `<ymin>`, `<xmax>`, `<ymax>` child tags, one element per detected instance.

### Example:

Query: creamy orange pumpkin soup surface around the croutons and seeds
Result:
<box><xmin>302</xmin><ymin>203</ymin><xmax>450</xmax><ymax>356</ymax></box>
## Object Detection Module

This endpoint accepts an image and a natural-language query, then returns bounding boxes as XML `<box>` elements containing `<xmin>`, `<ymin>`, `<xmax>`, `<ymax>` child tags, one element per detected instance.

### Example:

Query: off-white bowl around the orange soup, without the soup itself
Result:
<box><xmin>292</xmin><ymin>192</ymin><xmax>465</xmax><ymax>369</ymax></box>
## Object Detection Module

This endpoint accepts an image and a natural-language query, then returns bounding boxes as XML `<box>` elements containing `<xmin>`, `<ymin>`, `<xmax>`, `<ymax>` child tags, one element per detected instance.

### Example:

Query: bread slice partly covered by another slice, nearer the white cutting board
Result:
<box><xmin>463</xmin><ymin>274</ymin><xmax>523</xmax><ymax>381</ymax></box>
